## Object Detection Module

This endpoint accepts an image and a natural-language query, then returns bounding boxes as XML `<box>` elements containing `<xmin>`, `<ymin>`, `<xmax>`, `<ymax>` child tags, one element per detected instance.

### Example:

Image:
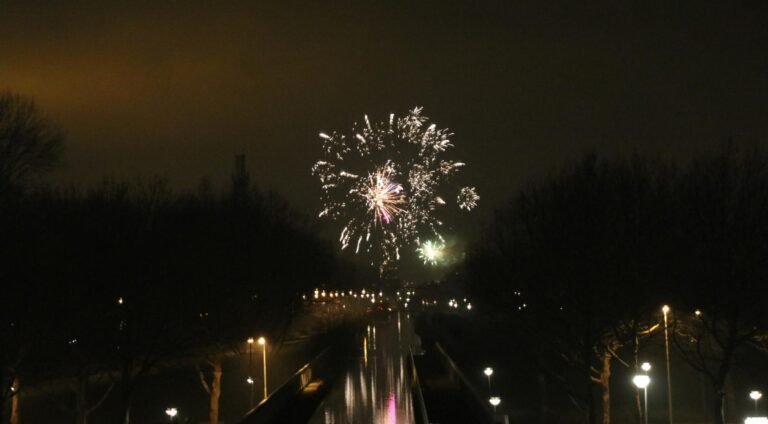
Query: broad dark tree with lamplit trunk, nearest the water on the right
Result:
<box><xmin>462</xmin><ymin>155</ymin><xmax>671</xmax><ymax>424</ymax></box>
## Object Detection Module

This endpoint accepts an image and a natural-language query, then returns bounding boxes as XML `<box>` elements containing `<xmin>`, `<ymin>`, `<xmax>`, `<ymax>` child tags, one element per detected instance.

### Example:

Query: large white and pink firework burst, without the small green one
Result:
<box><xmin>312</xmin><ymin>108</ymin><xmax>480</xmax><ymax>267</ymax></box>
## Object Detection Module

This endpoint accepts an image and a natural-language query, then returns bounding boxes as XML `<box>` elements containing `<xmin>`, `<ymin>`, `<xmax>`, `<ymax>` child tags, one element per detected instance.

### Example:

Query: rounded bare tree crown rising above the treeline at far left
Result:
<box><xmin>0</xmin><ymin>92</ymin><xmax>64</xmax><ymax>189</ymax></box>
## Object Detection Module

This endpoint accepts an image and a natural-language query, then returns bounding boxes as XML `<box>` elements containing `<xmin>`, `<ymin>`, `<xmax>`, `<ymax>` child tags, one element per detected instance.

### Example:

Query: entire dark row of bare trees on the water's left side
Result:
<box><xmin>0</xmin><ymin>94</ymin><xmax>336</xmax><ymax>424</ymax></box>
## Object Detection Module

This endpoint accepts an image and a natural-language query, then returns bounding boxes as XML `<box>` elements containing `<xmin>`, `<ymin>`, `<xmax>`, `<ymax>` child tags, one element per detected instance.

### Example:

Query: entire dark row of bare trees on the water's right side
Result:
<box><xmin>467</xmin><ymin>144</ymin><xmax>768</xmax><ymax>424</ymax></box>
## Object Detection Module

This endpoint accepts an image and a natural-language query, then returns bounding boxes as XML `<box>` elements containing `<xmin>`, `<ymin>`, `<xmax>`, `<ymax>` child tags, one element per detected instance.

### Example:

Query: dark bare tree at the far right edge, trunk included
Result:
<box><xmin>675</xmin><ymin>143</ymin><xmax>768</xmax><ymax>424</ymax></box>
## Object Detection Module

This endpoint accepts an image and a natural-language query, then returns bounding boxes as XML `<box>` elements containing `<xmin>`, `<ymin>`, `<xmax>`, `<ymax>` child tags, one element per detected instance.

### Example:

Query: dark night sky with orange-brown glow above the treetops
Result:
<box><xmin>0</xmin><ymin>0</ymin><xmax>768</xmax><ymax>222</ymax></box>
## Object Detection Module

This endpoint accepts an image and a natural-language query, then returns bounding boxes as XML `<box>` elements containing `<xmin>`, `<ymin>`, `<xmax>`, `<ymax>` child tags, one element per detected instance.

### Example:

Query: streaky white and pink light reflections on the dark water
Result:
<box><xmin>309</xmin><ymin>313</ymin><xmax>414</xmax><ymax>424</ymax></box>
